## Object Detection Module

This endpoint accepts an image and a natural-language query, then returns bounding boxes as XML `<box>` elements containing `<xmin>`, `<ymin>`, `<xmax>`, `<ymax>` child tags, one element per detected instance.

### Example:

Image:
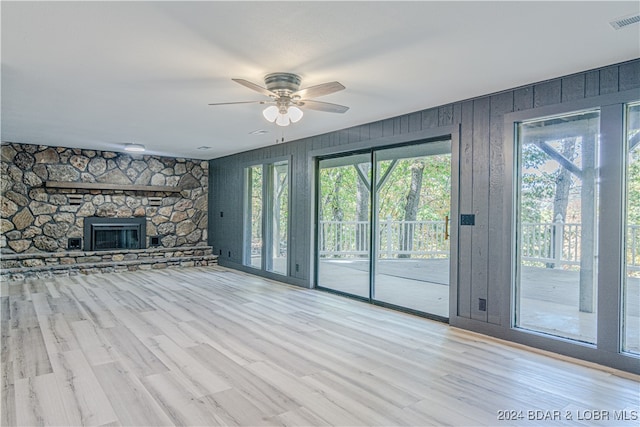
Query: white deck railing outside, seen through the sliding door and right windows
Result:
<box><xmin>318</xmin><ymin>218</ymin><xmax>640</xmax><ymax>270</ymax></box>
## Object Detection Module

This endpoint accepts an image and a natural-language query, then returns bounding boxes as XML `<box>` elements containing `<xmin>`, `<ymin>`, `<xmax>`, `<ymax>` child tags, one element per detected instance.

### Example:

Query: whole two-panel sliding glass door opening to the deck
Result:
<box><xmin>316</xmin><ymin>139</ymin><xmax>451</xmax><ymax>318</ymax></box>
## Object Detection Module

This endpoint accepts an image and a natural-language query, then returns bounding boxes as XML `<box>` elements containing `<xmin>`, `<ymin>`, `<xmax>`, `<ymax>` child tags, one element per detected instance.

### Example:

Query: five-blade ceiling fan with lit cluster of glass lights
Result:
<box><xmin>209</xmin><ymin>73</ymin><xmax>349</xmax><ymax>126</ymax></box>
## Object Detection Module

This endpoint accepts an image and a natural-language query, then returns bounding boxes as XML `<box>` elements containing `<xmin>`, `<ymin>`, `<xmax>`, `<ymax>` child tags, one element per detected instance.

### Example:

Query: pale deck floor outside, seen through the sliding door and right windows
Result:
<box><xmin>319</xmin><ymin>259</ymin><xmax>640</xmax><ymax>352</ymax></box>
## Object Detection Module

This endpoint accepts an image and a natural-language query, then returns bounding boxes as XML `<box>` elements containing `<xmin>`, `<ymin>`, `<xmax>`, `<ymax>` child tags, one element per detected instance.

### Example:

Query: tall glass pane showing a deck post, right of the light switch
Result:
<box><xmin>515</xmin><ymin>111</ymin><xmax>600</xmax><ymax>343</ymax></box>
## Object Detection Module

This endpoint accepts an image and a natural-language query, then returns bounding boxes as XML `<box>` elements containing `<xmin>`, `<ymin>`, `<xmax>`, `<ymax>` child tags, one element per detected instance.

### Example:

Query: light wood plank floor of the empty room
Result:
<box><xmin>0</xmin><ymin>267</ymin><xmax>640</xmax><ymax>426</ymax></box>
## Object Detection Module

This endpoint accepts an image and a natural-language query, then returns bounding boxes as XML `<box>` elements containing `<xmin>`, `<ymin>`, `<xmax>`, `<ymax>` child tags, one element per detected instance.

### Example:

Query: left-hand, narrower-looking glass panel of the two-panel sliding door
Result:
<box><xmin>317</xmin><ymin>153</ymin><xmax>371</xmax><ymax>298</ymax></box>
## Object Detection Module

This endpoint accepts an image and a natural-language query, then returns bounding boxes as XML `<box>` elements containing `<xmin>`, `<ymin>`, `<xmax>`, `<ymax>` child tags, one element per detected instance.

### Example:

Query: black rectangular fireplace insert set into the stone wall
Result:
<box><xmin>84</xmin><ymin>217</ymin><xmax>147</xmax><ymax>251</ymax></box>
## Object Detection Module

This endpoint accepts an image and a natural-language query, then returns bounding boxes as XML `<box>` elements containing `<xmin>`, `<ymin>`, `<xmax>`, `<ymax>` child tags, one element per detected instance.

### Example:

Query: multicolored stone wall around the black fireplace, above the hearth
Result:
<box><xmin>0</xmin><ymin>143</ymin><xmax>208</xmax><ymax>253</ymax></box>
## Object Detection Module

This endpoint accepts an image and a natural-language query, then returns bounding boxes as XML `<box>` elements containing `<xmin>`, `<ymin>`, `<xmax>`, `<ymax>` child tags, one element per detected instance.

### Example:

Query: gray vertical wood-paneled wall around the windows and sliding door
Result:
<box><xmin>209</xmin><ymin>59</ymin><xmax>640</xmax><ymax>369</ymax></box>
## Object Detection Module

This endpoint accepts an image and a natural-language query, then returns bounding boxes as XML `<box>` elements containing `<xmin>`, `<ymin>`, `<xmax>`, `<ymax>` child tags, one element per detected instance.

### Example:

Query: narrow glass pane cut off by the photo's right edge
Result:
<box><xmin>622</xmin><ymin>104</ymin><xmax>640</xmax><ymax>354</ymax></box>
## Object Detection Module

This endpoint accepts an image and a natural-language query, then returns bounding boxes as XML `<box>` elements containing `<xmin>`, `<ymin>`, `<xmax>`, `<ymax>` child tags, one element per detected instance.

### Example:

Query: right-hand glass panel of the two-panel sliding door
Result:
<box><xmin>372</xmin><ymin>140</ymin><xmax>451</xmax><ymax>318</ymax></box>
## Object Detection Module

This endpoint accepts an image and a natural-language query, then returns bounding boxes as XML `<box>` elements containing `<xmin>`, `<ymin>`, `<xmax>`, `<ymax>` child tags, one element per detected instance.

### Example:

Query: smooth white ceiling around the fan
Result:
<box><xmin>0</xmin><ymin>1</ymin><xmax>640</xmax><ymax>159</ymax></box>
